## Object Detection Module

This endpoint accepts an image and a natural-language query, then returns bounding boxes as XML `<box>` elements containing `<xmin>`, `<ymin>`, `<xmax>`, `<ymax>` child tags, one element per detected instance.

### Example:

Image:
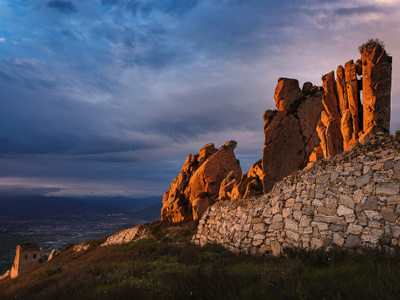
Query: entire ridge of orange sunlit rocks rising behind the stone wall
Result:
<box><xmin>161</xmin><ymin>40</ymin><xmax>392</xmax><ymax>222</ymax></box>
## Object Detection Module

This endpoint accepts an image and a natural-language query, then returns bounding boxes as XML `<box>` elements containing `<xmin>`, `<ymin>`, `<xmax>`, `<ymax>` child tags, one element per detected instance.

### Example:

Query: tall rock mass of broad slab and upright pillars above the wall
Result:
<box><xmin>262</xmin><ymin>40</ymin><xmax>392</xmax><ymax>192</ymax></box>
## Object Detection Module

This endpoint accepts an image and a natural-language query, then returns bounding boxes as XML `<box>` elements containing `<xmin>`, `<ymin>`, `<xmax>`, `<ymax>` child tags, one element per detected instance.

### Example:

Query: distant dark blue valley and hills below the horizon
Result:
<box><xmin>0</xmin><ymin>195</ymin><xmax>162</xmax><ymax>273</ymax></box>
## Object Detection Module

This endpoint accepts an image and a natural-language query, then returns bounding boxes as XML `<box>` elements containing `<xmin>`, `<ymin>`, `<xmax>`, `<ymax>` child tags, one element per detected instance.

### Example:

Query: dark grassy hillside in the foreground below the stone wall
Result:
<box><xmin>0</xmin><ymin>221</ymin><xmax>400</xmax><ymax>299</ymax></box>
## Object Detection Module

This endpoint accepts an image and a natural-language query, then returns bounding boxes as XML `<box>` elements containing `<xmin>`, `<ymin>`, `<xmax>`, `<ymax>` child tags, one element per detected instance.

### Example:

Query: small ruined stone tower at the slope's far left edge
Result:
<box><xmin>11</xmin><ymin>243</ymin><xmax>41</xmax><ymax>278</ymax></box>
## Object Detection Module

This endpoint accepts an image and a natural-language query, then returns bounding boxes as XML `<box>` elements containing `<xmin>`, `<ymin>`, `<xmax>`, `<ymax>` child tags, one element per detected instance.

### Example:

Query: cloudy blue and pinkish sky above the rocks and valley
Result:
<box><xmin>0</xmin><ymin>0</ymin><xmax>400</xmax><ymax>197</ymax></box>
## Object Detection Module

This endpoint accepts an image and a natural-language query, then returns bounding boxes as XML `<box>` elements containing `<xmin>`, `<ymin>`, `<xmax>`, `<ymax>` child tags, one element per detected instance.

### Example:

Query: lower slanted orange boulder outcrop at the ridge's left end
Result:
<box><xmin>161</xmin><ymin>141</ymin><xmax>242</xmax><ymax>222</ymax></box>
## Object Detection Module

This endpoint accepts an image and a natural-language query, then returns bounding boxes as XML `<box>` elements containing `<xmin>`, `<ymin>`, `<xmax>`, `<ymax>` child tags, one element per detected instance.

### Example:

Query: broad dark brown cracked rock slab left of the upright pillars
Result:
<box><xmin>262</xmin><ymin>78</ymin><xmax>323</xmax><ymax>192</ymax></box>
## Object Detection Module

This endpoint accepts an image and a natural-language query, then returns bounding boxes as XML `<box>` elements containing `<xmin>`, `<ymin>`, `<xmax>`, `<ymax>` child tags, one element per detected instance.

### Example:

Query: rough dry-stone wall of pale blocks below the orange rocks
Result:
<box><xmin>193</xmin><ymin>133</ymin><xmax>400</xmax><ymax>255</ymax></box>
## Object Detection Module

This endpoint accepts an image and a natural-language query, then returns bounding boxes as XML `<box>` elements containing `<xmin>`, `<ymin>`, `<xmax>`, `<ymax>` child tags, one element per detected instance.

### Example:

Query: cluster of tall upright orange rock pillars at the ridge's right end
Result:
<box><xmin>317</xmin><ymin>40</ymin><xmax>392</xmax><ymax>157</ymax></box>
